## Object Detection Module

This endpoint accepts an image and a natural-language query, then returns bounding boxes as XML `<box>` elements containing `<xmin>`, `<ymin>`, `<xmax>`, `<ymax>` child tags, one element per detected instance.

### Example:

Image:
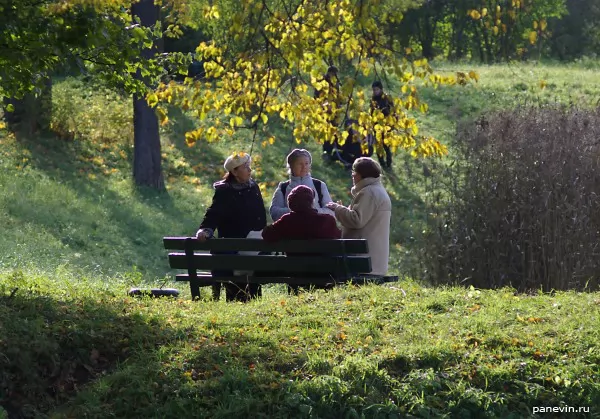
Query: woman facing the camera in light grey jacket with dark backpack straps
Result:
<box><xmin>269</xmin><ymin>148</ymin><xmax>333</xmax><ymax>221</ymax></box>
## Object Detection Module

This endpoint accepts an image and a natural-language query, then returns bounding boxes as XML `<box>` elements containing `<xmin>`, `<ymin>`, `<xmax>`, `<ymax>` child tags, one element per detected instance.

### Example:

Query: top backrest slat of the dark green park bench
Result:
<box><xmin>163</xmin><ymin>237</ymin><xmax>369</xmax><ymax>255</ymax></box>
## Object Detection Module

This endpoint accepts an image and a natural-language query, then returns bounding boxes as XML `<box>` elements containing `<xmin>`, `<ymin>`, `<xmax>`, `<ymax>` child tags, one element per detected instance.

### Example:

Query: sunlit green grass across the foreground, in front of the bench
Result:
<box><xmin>0</xmin><ymin>274</ymin><xmax>600</xmax><ymax>418</ymax></box>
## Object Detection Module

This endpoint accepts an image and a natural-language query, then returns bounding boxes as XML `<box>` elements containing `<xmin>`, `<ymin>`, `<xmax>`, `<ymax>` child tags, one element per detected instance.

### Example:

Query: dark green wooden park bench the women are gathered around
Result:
<box><xmin>163</xmin><ymin>237</ymin><xmax>398</xmax><ymax>299</ymax></box>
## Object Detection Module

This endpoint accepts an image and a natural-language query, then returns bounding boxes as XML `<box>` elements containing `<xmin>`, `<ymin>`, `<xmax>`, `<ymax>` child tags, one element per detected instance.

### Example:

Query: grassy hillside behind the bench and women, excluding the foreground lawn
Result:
<box><xmin>0</xmin><ymin>64</ymin><xmax>600</xmax><ymax>288</ymax></box>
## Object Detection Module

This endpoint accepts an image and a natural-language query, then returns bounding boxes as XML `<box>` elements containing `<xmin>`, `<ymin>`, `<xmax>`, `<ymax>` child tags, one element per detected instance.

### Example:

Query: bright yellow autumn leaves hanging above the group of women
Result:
<box><xmin>147</xmin><ymin>0</ymin><xmax>478</xmax><ymax>156</ymax></box>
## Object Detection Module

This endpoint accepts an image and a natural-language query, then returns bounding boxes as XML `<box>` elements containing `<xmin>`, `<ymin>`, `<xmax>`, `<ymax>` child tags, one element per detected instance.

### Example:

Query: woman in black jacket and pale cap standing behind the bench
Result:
<box><xmin>196</xmin><ymin>153</ymin><xmax>267</xmax><ymax>301</ymax></box>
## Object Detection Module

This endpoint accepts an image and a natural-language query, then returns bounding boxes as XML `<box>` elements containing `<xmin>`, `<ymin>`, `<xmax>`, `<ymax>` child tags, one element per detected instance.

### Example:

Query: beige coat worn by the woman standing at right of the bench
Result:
<box><xmin>335</xmin><ymin>178</ymin><xmax>392</xmax><ymax>275</ymax></box>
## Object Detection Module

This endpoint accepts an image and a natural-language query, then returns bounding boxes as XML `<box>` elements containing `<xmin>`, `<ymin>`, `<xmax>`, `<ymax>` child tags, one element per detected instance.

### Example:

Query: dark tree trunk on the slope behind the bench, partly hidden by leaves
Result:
<box><xmin>131</xmin><ymin>0</ymin><xmax>165</xmax><ymax>190</ymax></box>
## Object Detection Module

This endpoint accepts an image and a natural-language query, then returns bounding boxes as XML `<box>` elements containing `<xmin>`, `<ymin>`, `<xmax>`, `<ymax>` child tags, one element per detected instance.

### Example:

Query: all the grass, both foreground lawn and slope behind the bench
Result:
<box><xmin>0</xmin><ymin>61</ymin><xmax>600</xmax><ymax>417</ymax></box>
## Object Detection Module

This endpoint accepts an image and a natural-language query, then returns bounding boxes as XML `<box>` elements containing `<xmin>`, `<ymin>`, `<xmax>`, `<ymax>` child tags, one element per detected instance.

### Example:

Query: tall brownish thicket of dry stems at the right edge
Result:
<box><xmin>423</xmin><ymin>108</ymin><xmax>600</xmax><ymax>291</ymax></box>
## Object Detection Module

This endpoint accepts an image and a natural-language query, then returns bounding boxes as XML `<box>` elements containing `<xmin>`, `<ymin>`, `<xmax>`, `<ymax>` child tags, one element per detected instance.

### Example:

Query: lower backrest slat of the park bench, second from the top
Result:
<box><xmin>169</xmin><ymin>253</ymin><xmax>371</xmax><ymax>277</ymax></box>
